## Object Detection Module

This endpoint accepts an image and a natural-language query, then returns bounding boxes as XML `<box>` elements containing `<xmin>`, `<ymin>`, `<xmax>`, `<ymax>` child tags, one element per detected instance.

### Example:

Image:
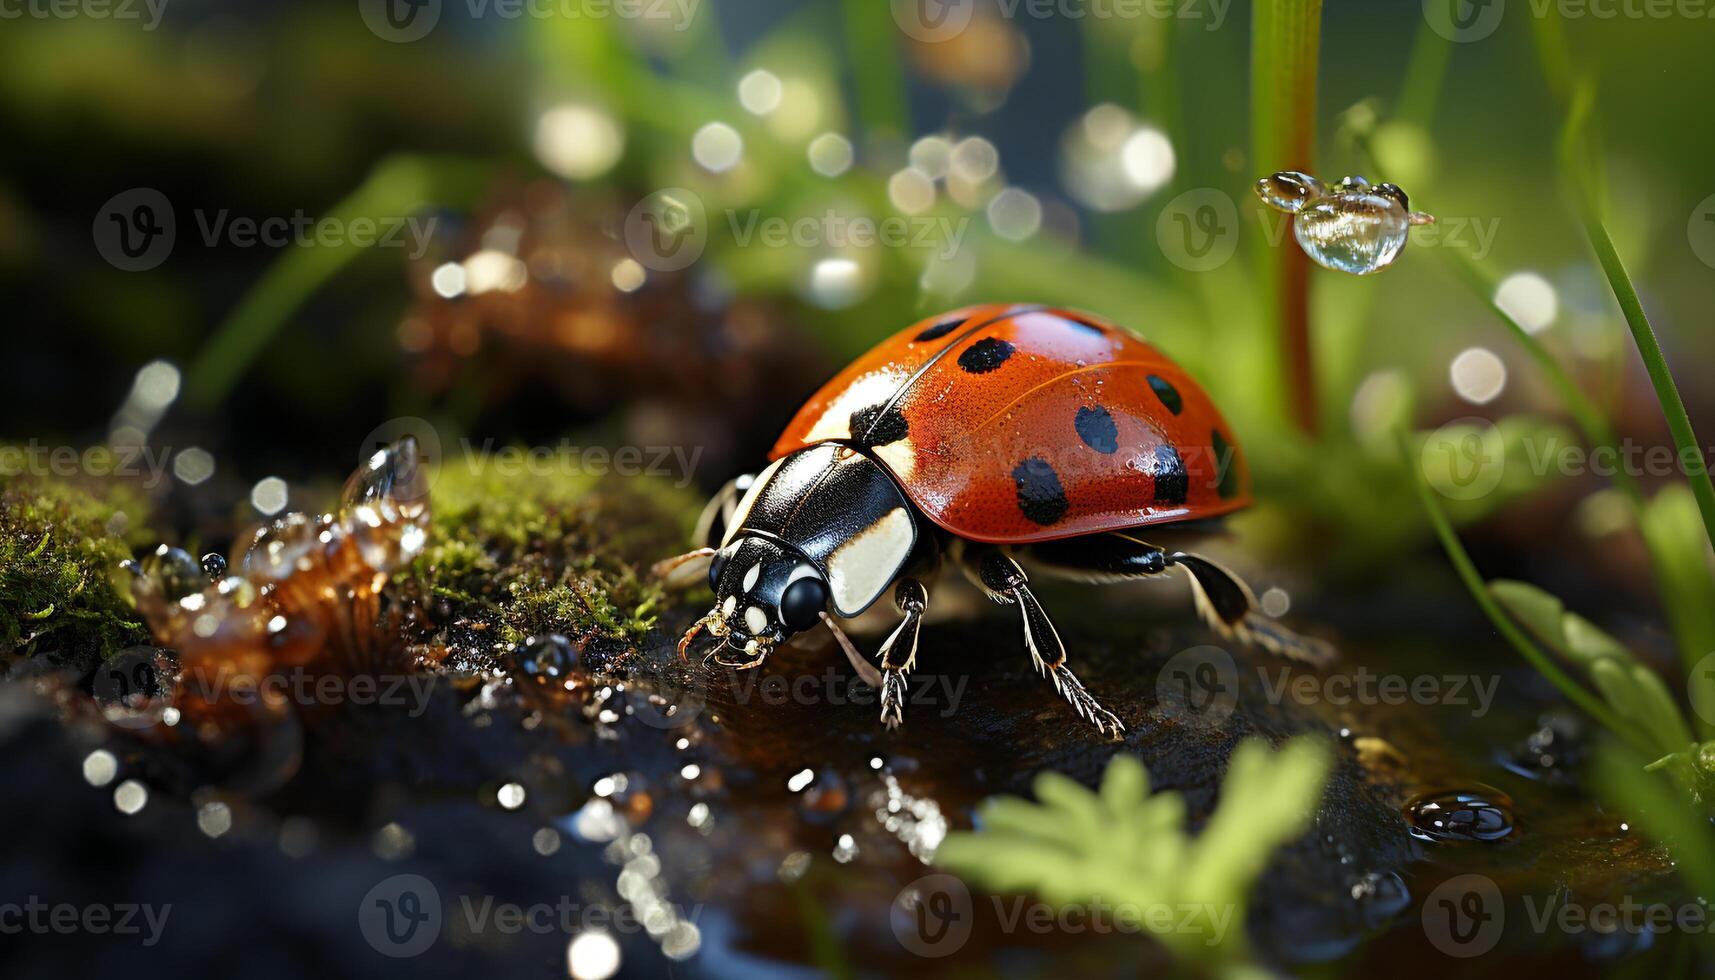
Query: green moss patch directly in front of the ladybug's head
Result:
<box><xmin>408</xmin><ymin>458</ymin><xmax>700</xmax><ymax>645</ymax></box>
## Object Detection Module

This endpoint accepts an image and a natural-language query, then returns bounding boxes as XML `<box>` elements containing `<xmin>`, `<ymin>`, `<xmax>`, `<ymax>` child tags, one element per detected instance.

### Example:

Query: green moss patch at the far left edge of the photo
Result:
<box><xmin>0</xmin><ymin>475</ymin><xmax>147</xmax><ymax>661</ymax></box>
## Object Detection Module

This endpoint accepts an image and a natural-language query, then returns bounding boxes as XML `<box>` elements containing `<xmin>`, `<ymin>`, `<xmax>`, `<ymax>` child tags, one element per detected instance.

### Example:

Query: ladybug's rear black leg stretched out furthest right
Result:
<box><xmin>1027</xmin><ymin>532</ymin><xmax>1334</xmax><ymax>664</ymax></box>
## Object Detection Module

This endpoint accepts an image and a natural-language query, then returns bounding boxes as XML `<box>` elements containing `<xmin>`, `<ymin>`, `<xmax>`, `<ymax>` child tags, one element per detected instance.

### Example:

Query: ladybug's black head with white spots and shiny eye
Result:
<box><xmin>705</xmin><ymin>534</ymin><xmax>828</xmax><ymax>662</ymax></box>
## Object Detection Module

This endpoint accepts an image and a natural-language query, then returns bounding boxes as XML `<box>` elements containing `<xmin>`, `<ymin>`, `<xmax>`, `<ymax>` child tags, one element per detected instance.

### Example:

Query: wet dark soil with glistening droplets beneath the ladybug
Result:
<box><xmin>0</xmin><ymin>562</ymin><xmax>1674</xmax><ymax>977</ymax></box>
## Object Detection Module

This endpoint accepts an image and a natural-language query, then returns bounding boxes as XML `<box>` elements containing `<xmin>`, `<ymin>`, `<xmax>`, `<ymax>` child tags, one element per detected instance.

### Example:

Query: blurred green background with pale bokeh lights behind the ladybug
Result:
<box><xmin>0</xmin><ymin>0</ymin><xmax>1715</xmax><ymax>599</ymax></box>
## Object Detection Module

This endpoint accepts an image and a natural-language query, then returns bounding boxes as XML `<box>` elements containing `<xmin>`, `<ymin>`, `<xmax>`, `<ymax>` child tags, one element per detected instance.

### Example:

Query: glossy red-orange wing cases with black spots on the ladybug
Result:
<box><xmin>768</xmin><ymin>305</ymin><xmax>1250</xmax><ymax>544</ymax></box>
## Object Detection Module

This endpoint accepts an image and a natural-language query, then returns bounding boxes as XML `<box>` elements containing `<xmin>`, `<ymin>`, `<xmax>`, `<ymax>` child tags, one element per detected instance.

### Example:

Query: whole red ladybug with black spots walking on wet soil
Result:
<box><xmin>657</xmin><ymin>305</ymin><xmax>1329</xmax><ymax>735</ymax></box>
